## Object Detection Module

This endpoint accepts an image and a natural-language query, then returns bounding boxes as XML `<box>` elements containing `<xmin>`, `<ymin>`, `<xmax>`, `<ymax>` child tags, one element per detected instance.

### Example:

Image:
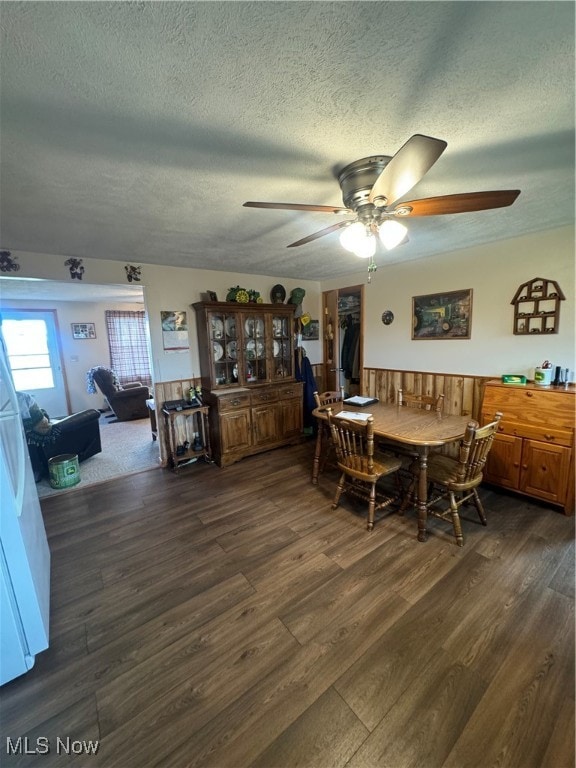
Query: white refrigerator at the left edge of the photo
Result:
<box><xmin>0</xmin><ymin>334</ymin><xmax>50</xmax><ymax>685</ymax></box>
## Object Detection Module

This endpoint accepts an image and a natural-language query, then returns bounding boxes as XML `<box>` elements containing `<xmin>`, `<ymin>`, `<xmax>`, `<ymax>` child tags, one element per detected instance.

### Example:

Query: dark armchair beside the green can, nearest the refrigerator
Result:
<box><xmin>17</xmin><ymin>392</ymin><xmax>102</xmax><ymax>482</ymax></box>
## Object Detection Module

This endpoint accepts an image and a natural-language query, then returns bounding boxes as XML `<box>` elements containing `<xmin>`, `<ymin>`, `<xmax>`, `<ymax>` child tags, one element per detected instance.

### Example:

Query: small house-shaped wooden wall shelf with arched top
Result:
<box><xmin>510</xmin><ymin>277</ymin><xmax>564</xmax><ymax>336</ymax></box>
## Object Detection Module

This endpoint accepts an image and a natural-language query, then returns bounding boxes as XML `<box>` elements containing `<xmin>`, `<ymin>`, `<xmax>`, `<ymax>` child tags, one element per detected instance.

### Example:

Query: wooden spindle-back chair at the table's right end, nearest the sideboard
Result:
<box><xmin>409</xmin><ymin>412</ymin><xmax>502</xmax><ymax>547</ymax></box>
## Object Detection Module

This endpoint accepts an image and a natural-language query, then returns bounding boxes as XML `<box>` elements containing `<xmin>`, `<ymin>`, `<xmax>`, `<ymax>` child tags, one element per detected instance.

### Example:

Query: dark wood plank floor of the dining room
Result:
<box><xmin>0</xmin><ymin>443</ymin><xmax>574</xmax><ymax>768</ymax></box>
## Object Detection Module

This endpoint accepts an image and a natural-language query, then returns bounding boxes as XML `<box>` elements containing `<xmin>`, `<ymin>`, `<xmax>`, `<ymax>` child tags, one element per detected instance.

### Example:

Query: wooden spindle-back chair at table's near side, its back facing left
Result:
<box><xmin>326</xmin><ymin>407</ymin><xmax>402</xmax><ymax>531</ymax></box>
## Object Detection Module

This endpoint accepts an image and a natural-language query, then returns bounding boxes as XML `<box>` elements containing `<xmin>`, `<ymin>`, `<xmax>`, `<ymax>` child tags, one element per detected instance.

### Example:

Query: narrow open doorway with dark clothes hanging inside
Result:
<box><xmin>322</xmin><ymin>285</ymin><xmax>364</xmax><ymax>396</ymax></box>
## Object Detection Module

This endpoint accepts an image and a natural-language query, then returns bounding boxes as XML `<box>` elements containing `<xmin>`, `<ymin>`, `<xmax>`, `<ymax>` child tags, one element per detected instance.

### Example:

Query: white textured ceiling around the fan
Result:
<box><xmin>0</xmin><ymin>2</ymin><xmax>574</xmax><ymax>279</ymax></box>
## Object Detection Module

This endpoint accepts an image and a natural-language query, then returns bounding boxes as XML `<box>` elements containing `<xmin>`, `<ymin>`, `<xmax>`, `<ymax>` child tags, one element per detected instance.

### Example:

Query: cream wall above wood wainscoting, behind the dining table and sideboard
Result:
<box><xmin>322</xmin><ymin>227</ymin><xmax>575</xmax><ymax>378</ymax></box>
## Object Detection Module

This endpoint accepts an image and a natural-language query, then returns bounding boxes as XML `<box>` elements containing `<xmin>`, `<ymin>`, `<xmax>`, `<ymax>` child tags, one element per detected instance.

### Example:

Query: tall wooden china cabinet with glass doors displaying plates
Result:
<box><xmin>193</xmin><ymin>302</ymin><xmax>303</xmax><ymax>466</ymax></box>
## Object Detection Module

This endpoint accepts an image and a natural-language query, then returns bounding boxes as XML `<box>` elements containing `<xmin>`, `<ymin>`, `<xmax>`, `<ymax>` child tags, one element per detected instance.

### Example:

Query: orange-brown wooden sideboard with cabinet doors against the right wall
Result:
<box><xmin>481</xmin><ymin>381</ymin><xmax>576</xmax><ymax>515</ymax></box>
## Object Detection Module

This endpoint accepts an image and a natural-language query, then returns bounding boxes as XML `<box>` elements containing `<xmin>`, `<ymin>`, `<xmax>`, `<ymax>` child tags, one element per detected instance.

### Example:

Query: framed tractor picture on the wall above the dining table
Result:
<box><xmin>412</xmin><ymin>288</ymin><xmax>472</xmax><ymax>339</ymax></box>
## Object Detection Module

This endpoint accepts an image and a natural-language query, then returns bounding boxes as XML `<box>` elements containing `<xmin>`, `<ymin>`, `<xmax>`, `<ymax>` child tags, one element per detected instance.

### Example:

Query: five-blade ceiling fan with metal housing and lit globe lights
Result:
<box><xmin>244</xmin><ymin>133</ymin><xmax>520</xmax><ymax>260</ymax></box>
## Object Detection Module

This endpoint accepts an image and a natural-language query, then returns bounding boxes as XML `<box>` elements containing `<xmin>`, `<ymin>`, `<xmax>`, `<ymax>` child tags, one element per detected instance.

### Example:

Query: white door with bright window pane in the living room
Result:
<box><xmin>2</xmin><ymin>308</ymin><xmax>70</xmax><ymax>418</ymax></box>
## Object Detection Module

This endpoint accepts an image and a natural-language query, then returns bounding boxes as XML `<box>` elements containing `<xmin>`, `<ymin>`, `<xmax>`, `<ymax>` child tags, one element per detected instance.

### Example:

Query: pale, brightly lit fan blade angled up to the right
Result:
<box><xmin>368</xmin><ymin>133</ymin><xmax>448</xmax><ymax>207</ymax></box>
